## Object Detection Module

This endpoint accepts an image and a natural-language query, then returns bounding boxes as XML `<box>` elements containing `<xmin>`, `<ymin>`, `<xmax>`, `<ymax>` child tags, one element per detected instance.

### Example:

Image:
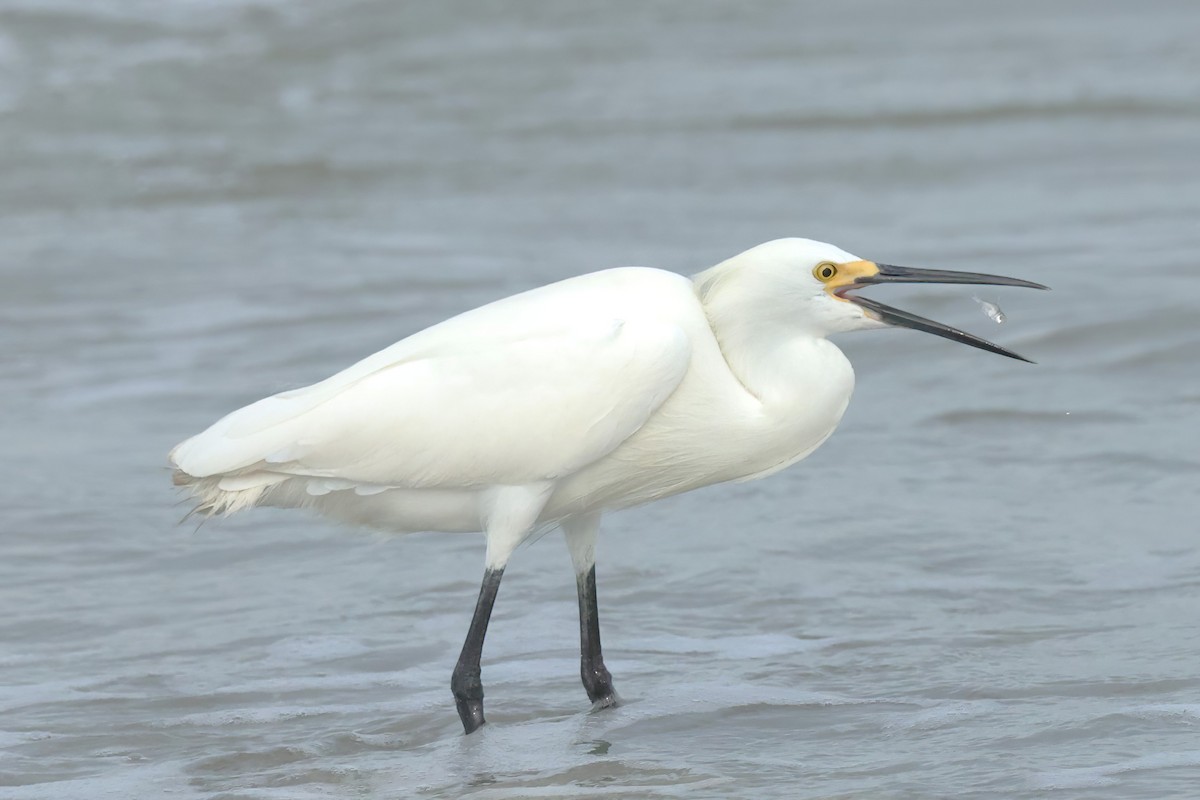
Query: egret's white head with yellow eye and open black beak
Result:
<box><xmin>696</xmin><ymin>239</ymin><xmax>1046</xmax><ymax>361</ymax></box>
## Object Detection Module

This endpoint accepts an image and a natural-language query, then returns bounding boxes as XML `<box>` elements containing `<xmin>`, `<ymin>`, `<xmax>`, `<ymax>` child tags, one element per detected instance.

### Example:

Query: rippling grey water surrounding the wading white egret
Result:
<box><xmin>0</xmin><ymin>0</ymin><xmax>1200</xmax><ymax>800</ymax></box>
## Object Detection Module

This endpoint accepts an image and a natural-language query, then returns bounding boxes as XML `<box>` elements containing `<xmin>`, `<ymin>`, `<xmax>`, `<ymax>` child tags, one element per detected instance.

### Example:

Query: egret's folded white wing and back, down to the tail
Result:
<box><xmin>170</xmin><ymin>267</ymin><xmax>702</xmax><ymax>527</ymax></box>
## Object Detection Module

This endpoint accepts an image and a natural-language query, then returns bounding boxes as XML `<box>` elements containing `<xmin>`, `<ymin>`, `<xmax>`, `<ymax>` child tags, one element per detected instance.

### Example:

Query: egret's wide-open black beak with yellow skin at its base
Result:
<box><xmin>827</xmin><ymin>261</ymin><xmax>1049</xmax><ymax>363</ymax></box>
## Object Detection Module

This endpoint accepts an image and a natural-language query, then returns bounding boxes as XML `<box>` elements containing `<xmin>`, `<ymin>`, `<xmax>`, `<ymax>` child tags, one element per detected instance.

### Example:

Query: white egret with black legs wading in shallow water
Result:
<box><xmin>170</xmin><ymin>239</ymin><xmax>1045</xmax><ymax>733</ymax></box>
